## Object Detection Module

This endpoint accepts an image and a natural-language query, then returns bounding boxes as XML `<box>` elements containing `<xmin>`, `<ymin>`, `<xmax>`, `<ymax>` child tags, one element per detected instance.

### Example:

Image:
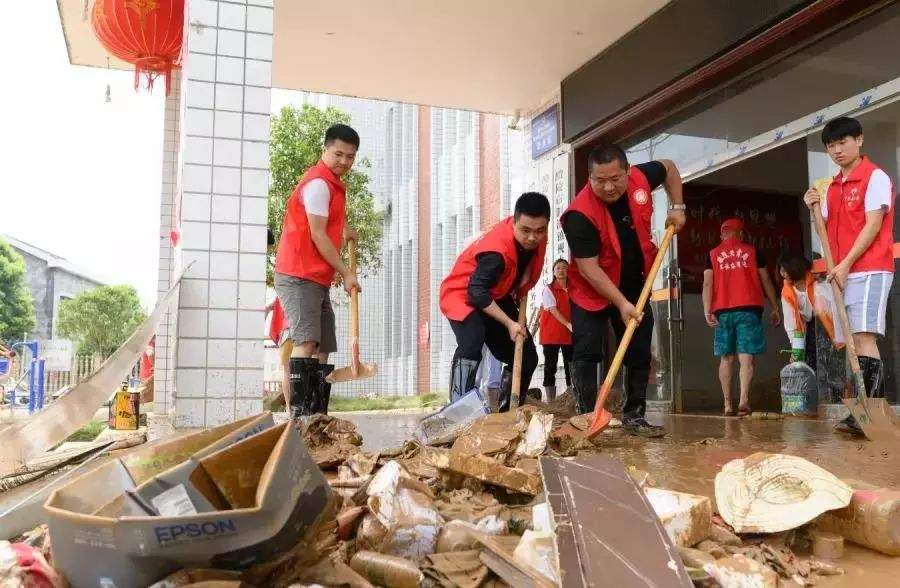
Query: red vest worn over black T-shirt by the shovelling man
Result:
<box><xmin>560</xmin><ymin>166</ymin><xmax>657</xmax><ymax>311</ymax></box>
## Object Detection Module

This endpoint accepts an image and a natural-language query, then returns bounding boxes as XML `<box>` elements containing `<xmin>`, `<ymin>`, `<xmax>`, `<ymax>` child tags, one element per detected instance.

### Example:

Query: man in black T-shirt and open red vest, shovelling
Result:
<box><xmin>560</xmin><ymin>145</ymin><xmax>685</xmax><ymax>437</ymax></box>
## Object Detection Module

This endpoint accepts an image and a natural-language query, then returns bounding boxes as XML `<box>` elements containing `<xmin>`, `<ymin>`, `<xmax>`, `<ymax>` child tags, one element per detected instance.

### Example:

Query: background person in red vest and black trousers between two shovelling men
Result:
<box><xmin>538</xmin><ymin>259</ymin><xmax>572</xmax><ymax>402</ymax></box>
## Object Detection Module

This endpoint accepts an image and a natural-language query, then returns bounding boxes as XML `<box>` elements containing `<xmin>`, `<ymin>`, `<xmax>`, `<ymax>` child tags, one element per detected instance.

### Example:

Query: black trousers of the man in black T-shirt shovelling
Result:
<box><xmin>572</xmin><ymin>293</ymin><xmax>653</xmax><ymax>369</ymax></box>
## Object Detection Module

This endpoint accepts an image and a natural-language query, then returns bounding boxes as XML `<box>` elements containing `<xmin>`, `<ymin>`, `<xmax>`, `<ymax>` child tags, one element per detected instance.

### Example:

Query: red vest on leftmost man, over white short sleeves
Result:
<box><xmin>275</xmin><ymin>160</ymin><xmax>347</xmax><ymax>287</ymax></box>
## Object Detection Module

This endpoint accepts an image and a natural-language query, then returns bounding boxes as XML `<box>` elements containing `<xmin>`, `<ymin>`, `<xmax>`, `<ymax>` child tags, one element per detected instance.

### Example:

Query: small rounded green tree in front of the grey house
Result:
<box><xmin>56</xmin><ymin>285</ymin><xmax>147</xmax><ymax>358</ymax></box>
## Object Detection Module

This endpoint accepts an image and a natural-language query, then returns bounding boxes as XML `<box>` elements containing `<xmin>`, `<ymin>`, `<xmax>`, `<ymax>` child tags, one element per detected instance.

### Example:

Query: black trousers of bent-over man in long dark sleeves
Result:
<box><xmin>450</xmin><ymin>297</ymin><xmax>537</xmax><ymax>391</ymax></box>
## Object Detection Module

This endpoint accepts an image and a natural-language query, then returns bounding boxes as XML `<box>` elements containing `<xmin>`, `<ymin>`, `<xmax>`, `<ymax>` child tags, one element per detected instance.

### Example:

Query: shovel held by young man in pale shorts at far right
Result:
<box><xmin>813</xmin><ymin>198</ymin><xmax>900</xmax><ymax>441</ymax></box>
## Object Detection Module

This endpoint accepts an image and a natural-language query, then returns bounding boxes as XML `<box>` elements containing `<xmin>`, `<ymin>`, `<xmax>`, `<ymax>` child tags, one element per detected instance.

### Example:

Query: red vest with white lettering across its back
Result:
<box><xmin>709</xmin><ymin>237</ymin><xmax>763</xmax><ymax>313</ymax></box>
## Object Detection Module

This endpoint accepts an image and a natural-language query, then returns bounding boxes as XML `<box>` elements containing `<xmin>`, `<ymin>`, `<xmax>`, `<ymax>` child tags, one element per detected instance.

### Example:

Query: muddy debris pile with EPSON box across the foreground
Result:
<box><xmin>0</xmin><ymin>404</ymin><xmax>900</xmax><ymax>588</ymax></box>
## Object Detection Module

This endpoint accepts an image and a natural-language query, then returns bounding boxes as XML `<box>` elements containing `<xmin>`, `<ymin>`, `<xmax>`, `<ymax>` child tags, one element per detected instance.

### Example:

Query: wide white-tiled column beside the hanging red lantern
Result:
<box><xmin>175</xmin><ymin>0</ymin><xmax>274</xmax><ymax>427</ymax></box>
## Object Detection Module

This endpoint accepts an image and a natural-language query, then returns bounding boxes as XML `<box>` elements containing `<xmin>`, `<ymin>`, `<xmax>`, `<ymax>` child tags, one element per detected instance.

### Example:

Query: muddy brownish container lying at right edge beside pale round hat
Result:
<box><xmin>815</xmin><ymin>484</ymin><xmax>900</xmax><ymax>555</ymax></box>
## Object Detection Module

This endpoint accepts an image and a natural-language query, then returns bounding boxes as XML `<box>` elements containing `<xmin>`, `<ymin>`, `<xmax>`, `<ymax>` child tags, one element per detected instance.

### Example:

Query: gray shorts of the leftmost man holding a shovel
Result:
<box><xmin>275</xmin><ymin>272</ymin><xmax>337</xmax><ymax>353</ymax></box>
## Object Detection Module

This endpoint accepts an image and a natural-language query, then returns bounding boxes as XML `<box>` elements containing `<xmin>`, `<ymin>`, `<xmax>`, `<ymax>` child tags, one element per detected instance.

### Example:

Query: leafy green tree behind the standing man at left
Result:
<box><xmin>266</xmin><ymin>104</ymin><xmax>382</xmax><ymax>285</ymax></box>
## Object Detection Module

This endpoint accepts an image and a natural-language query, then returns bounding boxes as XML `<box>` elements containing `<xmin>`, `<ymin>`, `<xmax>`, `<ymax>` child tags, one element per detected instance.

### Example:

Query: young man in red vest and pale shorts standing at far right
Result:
<box><xmin>803</xmin><ymin>116</ymin><xmax>894</xmax><ymax>435</ymax></box>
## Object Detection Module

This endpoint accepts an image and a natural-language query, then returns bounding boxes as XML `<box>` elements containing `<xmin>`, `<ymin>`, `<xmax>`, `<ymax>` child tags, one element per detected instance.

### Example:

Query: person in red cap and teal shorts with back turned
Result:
<box><xmin>703</xmin><ymin>218</ymin><xmax>781</xmax><ymax>416</ymax></box>
